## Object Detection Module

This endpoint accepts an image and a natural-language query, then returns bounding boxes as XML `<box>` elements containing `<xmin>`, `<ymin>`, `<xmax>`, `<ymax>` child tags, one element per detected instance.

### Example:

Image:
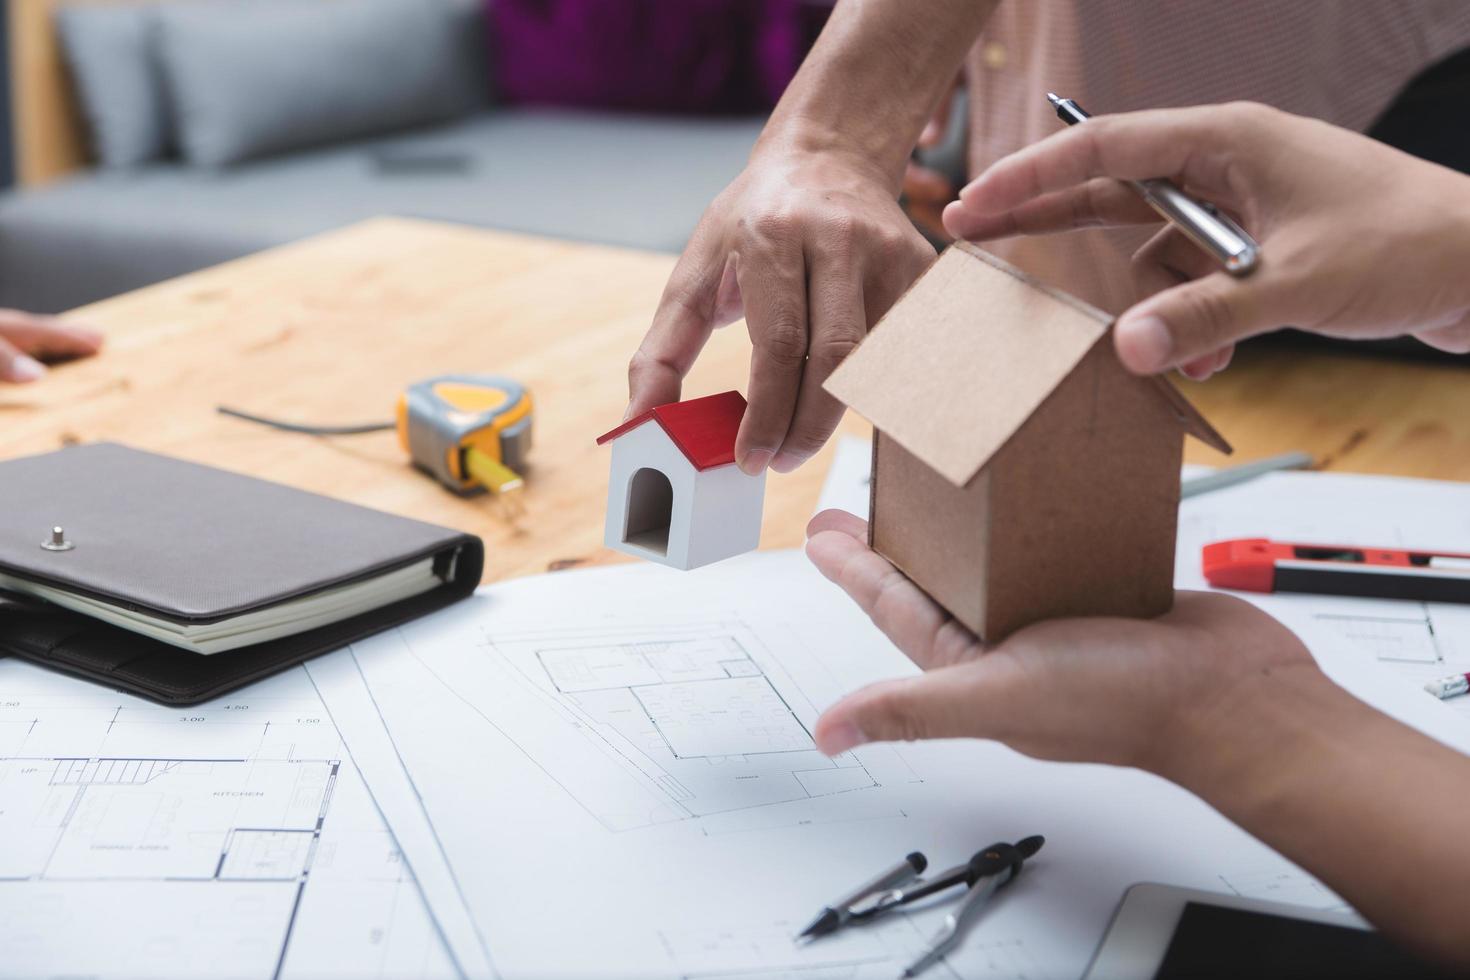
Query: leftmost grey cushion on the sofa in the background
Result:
<box><xmin>56</xmin><ymin>4</ymin><xmax>171</xmax><ymax>167</ymax></box>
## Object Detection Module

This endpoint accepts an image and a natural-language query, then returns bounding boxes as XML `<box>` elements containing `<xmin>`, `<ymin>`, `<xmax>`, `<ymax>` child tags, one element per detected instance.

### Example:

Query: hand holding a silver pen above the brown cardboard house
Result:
<box><xmin>945</xmin><ymin>103</ymin><xmax>1470</xmax><ymax>378</ymax></box>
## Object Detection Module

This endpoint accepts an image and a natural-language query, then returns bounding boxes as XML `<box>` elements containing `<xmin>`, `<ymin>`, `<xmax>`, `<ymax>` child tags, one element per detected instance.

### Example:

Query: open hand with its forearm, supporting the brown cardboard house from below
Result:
<box><xmin>807</xmin><ymin>510</ymin><xmax>1470</xmax><ymax>976</ymax></box>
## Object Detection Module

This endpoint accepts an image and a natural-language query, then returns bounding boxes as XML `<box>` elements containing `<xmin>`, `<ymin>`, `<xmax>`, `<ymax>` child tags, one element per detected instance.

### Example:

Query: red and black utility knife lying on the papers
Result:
<box><xmin>1204</xmin><ymin>538</ymin><xmax>1470</xmax><ymax>602</ymax></box>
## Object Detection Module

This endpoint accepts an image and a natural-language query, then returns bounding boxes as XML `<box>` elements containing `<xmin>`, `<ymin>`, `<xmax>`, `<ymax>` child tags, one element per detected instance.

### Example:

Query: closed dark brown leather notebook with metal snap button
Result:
<box><xmin>0</xmin><ymin>442</ymin><xmax>484</xmax><ymax>704</ymax></box>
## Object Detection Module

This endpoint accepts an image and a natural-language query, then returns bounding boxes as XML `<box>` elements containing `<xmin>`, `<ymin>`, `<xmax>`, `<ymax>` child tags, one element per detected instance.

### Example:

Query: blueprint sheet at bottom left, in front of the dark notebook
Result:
<box><xmin>0</xmin><ymin>660</ymin><xmax>459</xmax><ymax>979</ymax></box>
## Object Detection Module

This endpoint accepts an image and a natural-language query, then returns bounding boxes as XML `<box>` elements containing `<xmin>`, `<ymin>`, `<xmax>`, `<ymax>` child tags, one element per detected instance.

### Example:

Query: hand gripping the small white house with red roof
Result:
<box><xmin>628</xmin><ymin>147</ymin><xmax>933</xmax><ymax>475</ymax></box>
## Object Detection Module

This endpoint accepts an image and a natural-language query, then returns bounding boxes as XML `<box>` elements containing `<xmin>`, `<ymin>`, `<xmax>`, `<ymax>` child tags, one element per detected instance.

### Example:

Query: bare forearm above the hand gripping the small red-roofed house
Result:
<box><xmin>757</xmin><ymin>0</ymin><xmax>997</xmax><ymax>192</ymax></box>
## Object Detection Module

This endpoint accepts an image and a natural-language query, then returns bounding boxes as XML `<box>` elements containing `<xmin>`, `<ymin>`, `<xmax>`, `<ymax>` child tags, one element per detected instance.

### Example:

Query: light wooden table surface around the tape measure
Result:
<box><xmin>0</xmin><ymin>219</ymin><xmax>1470</xmax><ymax>579</ymax></box>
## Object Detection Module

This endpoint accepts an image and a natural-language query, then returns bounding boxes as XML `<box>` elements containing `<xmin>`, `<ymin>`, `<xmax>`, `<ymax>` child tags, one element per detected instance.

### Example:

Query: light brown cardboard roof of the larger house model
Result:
<box><xmin>825</xmin><ymin>242</ymin><xmax>1230</xmax><ymax>486</ymax></box>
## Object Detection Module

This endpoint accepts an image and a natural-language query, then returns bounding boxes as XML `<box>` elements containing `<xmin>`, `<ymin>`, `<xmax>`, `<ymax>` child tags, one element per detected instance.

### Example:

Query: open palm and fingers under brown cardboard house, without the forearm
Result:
<box><xmin>807</xmin><ymin>510</ymin><xmax>1320</xmax><ymax>783</ymax></box>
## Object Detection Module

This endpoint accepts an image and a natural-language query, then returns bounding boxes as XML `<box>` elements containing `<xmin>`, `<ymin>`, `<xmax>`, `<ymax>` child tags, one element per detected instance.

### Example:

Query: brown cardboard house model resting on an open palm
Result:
<box><xmin>826</xmin><ymin>242</ymin><xmax>1230</xmax><ymax>642</ymax></box>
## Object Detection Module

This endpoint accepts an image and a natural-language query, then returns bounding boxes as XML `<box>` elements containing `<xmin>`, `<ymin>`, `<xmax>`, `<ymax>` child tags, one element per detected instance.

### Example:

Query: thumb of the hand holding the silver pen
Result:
<box><xmin>1113</xmin><ymin>272</ymin><xmax>1280</xmax><ymax>375</ymax></box>
